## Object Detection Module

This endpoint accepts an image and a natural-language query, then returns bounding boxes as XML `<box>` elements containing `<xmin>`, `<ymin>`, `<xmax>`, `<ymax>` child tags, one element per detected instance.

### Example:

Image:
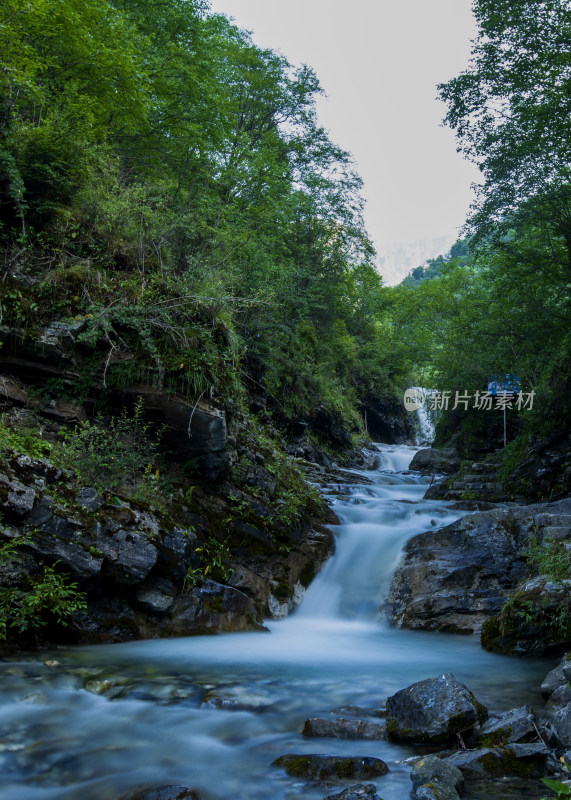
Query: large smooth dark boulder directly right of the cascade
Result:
<box><xmin>386</xmin><ymin>500</ymin><xmax>571</xmax><ymax>633</ymax></box>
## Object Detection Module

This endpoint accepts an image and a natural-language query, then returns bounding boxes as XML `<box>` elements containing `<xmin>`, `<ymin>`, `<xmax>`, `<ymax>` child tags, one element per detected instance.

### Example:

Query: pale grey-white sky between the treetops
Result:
<box><xmin>211</xmin><ymin>0</ymin><xmax>478</xmax><ymax>284</ymax></box>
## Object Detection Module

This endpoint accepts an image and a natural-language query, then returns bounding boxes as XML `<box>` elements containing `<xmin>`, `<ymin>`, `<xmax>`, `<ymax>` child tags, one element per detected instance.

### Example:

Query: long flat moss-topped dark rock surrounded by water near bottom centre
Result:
<box><xmin>272</xmin><ymin>753</ymin><xmax>389</xmax><ymax>780</ymax></box>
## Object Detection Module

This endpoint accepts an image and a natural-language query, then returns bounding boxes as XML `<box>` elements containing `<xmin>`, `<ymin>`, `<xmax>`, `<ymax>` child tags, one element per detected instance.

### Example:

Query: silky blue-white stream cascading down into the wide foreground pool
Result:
<box><xmin>0</xmin><ymin>445</ymin><xmax>549</xmax><ymax>800</ymax></box>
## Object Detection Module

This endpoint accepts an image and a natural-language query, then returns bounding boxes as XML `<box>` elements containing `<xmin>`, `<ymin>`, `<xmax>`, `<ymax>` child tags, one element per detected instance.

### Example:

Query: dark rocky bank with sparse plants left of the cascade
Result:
<box><xmin>0</xmin><ymin>323</ymin><xmax>348</xmax><ymax>646</ymax></box>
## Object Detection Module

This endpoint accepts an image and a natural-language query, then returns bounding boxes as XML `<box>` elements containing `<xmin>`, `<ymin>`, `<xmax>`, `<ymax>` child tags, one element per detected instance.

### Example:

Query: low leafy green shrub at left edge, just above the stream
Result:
<box><xmin>0</xmin><ymin>536</ymin><xmax>87</xmax><ymax>639</ymax></box>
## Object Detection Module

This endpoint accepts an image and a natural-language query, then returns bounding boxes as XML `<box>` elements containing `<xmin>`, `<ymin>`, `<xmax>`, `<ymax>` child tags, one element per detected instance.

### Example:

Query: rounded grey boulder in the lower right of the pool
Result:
<box><xmin>387</xmin><ymin>672</ymin><xmax>488</xmax><ymax>744</ymax></box>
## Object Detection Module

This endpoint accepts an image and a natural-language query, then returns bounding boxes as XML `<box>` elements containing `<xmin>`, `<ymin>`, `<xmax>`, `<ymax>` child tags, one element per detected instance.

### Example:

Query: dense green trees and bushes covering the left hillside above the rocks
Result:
<box><xmin>0</xmin><ymin>0</ymin><xmax>408</xmax><ymax>438</ymax></box>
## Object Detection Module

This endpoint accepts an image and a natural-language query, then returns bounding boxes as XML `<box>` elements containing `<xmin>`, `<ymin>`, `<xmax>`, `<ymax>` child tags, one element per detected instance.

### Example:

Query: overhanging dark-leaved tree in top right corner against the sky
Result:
<box><xmin>439</xmin><ymin>0</ymin><xmax>571</xmax><ymax>270</ymax></box>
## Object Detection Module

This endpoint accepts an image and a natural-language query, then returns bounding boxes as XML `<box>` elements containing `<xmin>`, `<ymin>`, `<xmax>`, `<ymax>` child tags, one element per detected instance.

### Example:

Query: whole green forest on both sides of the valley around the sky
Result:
<box><xmin>0</xmin><ymin>0</ymin><xmax>571</xmax><ymax>456</ymax></box>
